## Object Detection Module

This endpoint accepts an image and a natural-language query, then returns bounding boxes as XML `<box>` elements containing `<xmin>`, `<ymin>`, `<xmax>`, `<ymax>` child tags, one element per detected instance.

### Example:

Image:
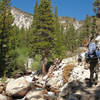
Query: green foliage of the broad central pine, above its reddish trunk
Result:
<box><xmin>37</xmin><ymin>0</ymin><xmax>54</xmax><ymax>53</ymax></box>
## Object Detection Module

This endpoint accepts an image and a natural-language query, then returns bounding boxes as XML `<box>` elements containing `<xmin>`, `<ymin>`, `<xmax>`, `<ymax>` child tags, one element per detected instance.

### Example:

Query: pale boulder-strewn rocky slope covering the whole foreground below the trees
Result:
<box><xmin>0</xmin><ymin>36</ymin><xmax>100</xmax><ymax>100</ymax></box>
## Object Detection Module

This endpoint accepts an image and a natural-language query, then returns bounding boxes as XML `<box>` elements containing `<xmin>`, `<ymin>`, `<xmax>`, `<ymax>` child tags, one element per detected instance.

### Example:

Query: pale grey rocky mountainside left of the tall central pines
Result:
<box><xmin>11</xmin><ymin>7</ymin><xmax>33</xmax><ymax>29</ymax></box>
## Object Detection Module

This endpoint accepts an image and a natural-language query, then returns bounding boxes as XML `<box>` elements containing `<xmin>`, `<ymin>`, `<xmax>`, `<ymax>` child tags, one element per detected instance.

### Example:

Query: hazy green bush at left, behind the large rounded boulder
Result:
<box><xmin>4</xmin><ymin>47</ymin><xmax>28</xmax><ymax>77</ymax></box>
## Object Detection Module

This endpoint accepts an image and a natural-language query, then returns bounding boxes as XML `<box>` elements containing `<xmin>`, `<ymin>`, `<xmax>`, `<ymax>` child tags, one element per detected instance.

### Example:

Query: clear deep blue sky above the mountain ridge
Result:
<box><xmin>11</xmin><ymin>0</ymin><xmax>95</xmax><ymax>20</ymax></box>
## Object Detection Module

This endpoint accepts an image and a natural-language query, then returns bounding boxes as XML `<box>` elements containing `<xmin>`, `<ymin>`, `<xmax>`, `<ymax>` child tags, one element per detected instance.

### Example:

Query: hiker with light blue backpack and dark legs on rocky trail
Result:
<box><xmin>85</xmin><ymin>38</ymin><xmax>100</xmax><ymax>86</ymax></box>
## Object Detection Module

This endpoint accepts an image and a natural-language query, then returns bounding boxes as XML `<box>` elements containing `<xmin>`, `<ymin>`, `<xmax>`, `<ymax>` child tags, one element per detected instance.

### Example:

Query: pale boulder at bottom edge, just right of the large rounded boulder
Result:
<box><xmin>25</xmin><ymin>89</ymin><xmax>44</xmax><ymax>100</ymax></box>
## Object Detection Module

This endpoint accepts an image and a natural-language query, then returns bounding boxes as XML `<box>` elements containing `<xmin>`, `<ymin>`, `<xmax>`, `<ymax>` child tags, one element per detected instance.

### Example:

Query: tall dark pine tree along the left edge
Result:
<box><xmin>0</xmin><ymin>0</ymin><xmax>13</xmax><ymax>74</ymax></box>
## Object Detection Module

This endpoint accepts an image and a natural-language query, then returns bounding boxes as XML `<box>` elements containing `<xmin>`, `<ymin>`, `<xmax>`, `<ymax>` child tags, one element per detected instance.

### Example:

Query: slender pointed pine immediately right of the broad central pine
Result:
<box><xmin>53</xmin><ymin>6</ymin><xmax>66</xmax><ymax>57</ymax></box>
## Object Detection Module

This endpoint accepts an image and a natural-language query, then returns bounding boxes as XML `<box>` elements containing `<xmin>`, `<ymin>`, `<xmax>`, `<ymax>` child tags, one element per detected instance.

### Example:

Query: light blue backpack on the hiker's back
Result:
<box><xmin>88</xmin><ymin>42</ymin><xmax>97</xmax><ymax>58</ymax></box>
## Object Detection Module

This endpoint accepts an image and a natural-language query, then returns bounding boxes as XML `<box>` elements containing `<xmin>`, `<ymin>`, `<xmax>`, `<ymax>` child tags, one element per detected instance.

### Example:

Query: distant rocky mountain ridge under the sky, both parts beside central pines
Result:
<box><xmin>11</xmin><ymin>7</ymin><xmax>82</xmax><ymax>29</ymax></box>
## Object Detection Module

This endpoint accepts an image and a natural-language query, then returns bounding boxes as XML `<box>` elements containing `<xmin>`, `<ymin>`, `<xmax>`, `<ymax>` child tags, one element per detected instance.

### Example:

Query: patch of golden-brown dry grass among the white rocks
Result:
<box><xmin>63</xmin><ymin>64</ymin><xmax>75</xmax><ymax>83</ymax></box>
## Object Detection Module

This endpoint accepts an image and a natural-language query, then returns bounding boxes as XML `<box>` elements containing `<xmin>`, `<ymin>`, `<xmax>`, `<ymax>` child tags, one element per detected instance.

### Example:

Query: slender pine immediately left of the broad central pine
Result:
<box><xmin>28</xmin><ymin>0</ymin><xmax>39</xmax><ymax>57</ymax></box>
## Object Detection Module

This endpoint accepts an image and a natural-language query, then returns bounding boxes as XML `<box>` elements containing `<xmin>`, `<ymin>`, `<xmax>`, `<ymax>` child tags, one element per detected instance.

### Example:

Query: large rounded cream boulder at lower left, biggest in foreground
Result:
<box><xmin>6</xmin><ymin>77</ymin><xmax>30</xmax><ymax>97</ymax></box>
